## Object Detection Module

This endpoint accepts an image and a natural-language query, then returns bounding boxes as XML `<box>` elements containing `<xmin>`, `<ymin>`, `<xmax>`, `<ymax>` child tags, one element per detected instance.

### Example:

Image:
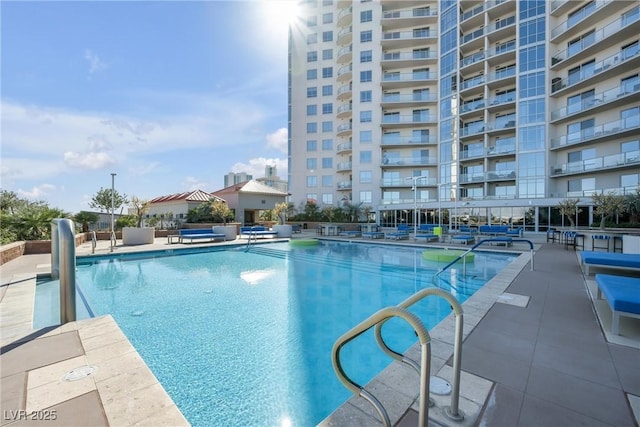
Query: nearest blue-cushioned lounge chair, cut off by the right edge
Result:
<box><xmin>596</xmin><ymin>274</ymin><xmax>640</xmax><ymax>335</ymax></box>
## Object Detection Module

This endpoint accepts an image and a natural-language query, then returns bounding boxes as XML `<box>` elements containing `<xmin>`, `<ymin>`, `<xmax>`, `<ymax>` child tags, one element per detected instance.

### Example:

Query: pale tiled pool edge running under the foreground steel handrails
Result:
<box><xmin>319</xmin><ymin>248</ymin><xmax>537</xmax><ymax>426</ymax></box>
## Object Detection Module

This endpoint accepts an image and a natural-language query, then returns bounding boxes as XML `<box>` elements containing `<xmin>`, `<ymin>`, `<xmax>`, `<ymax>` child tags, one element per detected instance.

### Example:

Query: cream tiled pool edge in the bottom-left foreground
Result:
<box><xmin>0</xmin><ymin>274</ymin><xmax>190</xmax><ymax>426</ymax></box>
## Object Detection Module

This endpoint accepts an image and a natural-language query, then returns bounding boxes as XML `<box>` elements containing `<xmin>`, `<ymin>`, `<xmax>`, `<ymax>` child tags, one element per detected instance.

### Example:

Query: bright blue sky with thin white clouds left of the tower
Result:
<box><xmin>0</xmin><ymin>0</ymin><xmax>292</xmax><ymax>214</ymax></box>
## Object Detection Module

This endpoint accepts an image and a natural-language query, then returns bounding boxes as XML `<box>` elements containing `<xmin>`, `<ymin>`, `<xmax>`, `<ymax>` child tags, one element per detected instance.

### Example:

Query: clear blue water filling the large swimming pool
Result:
<box><xmin>34</xmin><ymin>242</ymin><xmax>515</xmax><ymax>426</ymax></box>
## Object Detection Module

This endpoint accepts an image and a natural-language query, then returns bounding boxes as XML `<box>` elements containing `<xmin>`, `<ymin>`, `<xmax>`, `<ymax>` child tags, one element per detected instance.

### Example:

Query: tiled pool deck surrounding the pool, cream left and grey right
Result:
<box><xmin>0</xmin><ymin>236</ymin><xmax>640</xmax><ymax>427</ymax></box>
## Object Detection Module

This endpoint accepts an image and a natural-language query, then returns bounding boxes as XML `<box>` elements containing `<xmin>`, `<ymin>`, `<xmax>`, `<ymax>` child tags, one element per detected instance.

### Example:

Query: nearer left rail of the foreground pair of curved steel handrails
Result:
<box><xmin>331</xmin><ymin>306</ymin><xmax>431</xmax><ymax>427</ymax></box>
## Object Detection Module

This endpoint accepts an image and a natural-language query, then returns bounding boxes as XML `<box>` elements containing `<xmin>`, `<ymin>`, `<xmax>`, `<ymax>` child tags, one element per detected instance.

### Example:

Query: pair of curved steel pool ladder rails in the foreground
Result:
<box><xmin>331</xmin><ymin>288</ymin><xmax>464</xmax><ymax>427</ymax></box>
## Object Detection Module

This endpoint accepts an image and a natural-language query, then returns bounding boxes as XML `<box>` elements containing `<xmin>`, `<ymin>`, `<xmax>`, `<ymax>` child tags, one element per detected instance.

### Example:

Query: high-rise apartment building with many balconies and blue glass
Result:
<box><xmin>289</xmin><ymin>0</ymin><xmax>640</xmax><ymax>230</ymax></box>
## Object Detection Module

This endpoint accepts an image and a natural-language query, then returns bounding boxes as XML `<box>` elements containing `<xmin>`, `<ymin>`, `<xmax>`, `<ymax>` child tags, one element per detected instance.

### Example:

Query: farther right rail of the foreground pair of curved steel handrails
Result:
<box><xmin>374</xmin><ymin>288</ymin><xmax>464</xmax><ymax>422</ymax></box>
